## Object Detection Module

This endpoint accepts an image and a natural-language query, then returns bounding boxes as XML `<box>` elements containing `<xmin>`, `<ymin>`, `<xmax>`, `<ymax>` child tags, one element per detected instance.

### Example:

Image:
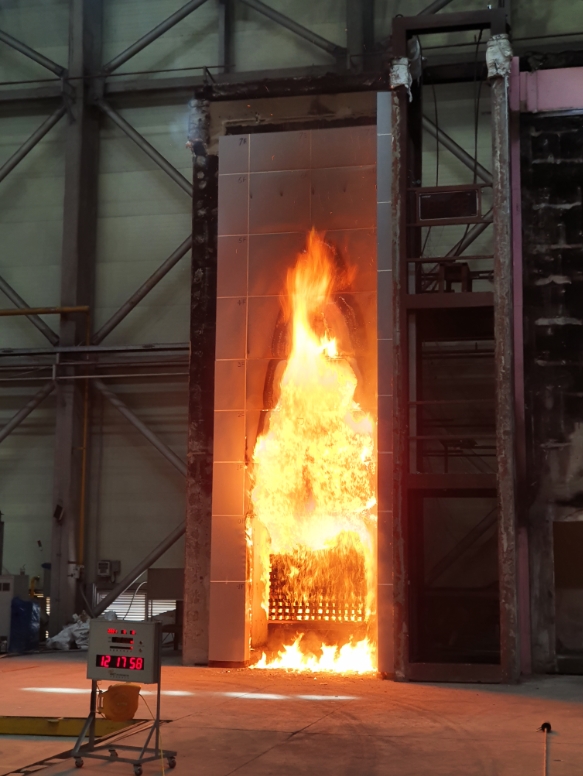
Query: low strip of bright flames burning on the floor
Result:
<box><xmin>251</xmin><ymin>634</ymin><xmax>376</xmax><ymax>674</ymax></box>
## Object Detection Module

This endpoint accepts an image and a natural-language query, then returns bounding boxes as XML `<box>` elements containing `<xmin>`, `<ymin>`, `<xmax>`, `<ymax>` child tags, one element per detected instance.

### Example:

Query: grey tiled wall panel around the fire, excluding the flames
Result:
<box><xmin>210</xmin><ymin>127</ymin><xmax>376</xmax><ymax>664</ymax></box>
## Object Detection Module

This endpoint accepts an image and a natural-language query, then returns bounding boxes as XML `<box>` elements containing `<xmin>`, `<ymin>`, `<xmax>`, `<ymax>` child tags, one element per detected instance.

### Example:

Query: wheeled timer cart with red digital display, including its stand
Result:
<box><xmin>71</xmin><ymin>620</ymin><xmax>176</xmax><ymax>776</ymax></box>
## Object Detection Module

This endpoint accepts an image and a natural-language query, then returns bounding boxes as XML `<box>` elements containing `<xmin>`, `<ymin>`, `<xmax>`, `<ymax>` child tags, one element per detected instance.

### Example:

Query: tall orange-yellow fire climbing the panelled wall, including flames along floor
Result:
<box><xmin>251</xmin><ymin>230</ymin><xmax>376</xmax><ymax>672</ymax></box>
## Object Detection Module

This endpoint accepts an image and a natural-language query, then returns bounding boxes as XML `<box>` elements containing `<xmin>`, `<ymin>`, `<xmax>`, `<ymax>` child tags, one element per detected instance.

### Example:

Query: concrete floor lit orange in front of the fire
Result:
<box><xmin>0</xmin><ymin>653</ymin><xmax>583</xmax><ymax>776</ymax></box>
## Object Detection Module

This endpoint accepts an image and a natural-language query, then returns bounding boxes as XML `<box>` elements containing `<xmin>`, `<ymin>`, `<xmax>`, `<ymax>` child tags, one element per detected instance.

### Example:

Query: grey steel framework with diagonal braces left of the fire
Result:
<box><xmin>0</xmin><ymin>0</ymin><xmax>392</xmax><ymax>638</ymax></box>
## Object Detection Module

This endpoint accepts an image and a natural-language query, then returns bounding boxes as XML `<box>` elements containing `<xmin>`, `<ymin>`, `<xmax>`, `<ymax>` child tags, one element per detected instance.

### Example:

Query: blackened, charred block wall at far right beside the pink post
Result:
<box><xmin>521</xmin><ymin>114</ymin><xmax>583</xmax><ymax>672</ymax></box>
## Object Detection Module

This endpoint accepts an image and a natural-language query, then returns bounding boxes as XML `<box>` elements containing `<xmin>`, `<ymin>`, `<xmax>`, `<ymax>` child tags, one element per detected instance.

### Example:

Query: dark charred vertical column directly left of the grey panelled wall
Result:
<box><xmin>182</xmin><ymin>100</ymin><xmax>218</xmax><ymax>665</ymax></box>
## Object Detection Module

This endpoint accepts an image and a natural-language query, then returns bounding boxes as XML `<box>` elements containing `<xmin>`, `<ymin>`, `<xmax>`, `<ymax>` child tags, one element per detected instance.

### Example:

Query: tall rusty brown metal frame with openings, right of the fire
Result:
<box><xmin>386</xmin><ymin>11</ymin><xmax>519</xmax><ymax>682</ymax></box>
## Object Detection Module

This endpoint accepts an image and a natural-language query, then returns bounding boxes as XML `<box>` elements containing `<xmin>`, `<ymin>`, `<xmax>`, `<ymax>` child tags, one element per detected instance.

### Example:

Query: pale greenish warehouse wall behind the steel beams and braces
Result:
<box><xmin>0</xmin><ymin>0</ymin><xmax>583</xmax><ymax>608</ymax></box>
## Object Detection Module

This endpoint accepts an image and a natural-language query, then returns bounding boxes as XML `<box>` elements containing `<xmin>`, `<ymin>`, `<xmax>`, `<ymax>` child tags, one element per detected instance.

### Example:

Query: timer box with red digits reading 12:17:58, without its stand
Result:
<box><xmin>87</xmin><ymin>620</ymin><xmax>161</xmax><ymax>684</ymax></box>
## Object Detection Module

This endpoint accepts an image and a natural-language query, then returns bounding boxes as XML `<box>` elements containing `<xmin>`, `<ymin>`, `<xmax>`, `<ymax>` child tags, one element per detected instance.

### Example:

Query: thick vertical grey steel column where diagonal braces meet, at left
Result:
<box><xmin>49</xmin><ymin>0</ymin><xmax>102</xmax><ymax>634</ymax></box>
